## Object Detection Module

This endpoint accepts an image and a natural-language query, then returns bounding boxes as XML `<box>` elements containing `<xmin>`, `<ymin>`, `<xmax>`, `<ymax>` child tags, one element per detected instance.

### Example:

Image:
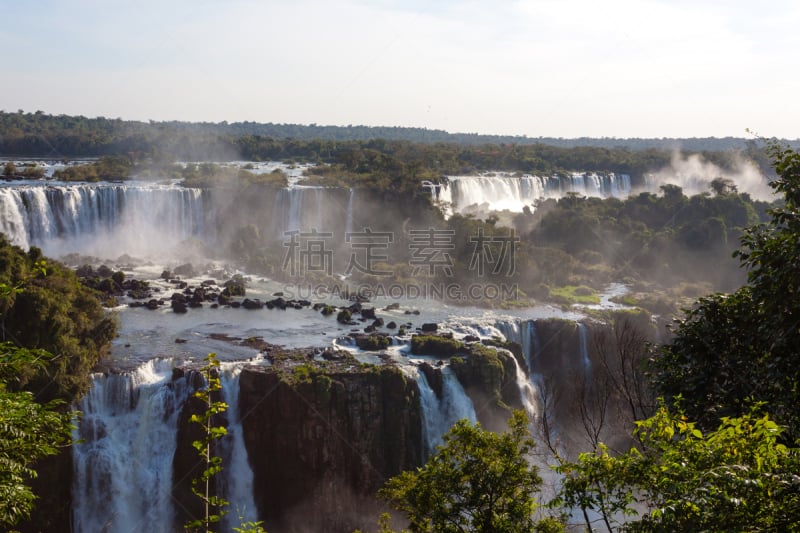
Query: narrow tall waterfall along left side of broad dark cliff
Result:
<box><xmin>220</xmin><ymin>363</ymin><xmax>258</xmax><ymax>531</ymax></box>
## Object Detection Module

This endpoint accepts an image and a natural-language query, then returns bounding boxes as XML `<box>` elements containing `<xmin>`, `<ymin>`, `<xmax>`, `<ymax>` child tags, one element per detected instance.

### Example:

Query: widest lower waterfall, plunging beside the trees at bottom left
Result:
<box><xmin>72</xmin><ymin>359</ymin><xmax>189</xmax><ymax>533</ymax></box>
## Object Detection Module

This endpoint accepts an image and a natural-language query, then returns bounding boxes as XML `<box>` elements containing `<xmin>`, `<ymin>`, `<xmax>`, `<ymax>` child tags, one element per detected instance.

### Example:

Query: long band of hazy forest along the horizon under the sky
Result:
<box><xmin>0</xmin><ymin>110</ymin><xmax>788</xmax><ymax>176</ymax></box>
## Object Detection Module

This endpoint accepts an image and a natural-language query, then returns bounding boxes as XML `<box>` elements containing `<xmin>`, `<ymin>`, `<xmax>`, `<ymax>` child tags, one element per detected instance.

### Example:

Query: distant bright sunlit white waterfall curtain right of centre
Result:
<box><xmin>444</xmin><ymin>172</ymin><xmax>631</xmax><ymax>212</ymax></box>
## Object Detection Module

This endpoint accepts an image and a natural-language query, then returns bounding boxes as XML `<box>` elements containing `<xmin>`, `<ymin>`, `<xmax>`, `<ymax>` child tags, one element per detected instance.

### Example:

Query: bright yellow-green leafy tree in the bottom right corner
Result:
<box><xmin>553</xmin><ymin>405</ymin><xmax>800</xmax><ymax>531</ymax></box>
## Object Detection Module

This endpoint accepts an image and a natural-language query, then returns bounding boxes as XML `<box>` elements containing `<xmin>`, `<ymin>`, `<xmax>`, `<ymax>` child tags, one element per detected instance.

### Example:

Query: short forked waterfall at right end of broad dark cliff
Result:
<box><xmin>413</xmin><ymin>367</ymin><xmax>478</xmax><ymax>454</ymax></box>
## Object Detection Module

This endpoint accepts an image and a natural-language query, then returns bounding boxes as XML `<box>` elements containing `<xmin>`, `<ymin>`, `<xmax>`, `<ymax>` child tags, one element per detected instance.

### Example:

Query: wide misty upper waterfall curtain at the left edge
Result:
<box><xmin>0</xmin><ymin>183</ymin><xmax>208</xmax><ymax>256</ymax></box>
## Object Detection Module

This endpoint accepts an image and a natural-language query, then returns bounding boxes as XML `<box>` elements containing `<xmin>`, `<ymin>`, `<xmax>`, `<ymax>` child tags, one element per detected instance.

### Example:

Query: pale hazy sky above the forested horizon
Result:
<box><xmin>0</xmin><ymin>0</ymin><xmax>800</xmax><ymax>138</ymax></box>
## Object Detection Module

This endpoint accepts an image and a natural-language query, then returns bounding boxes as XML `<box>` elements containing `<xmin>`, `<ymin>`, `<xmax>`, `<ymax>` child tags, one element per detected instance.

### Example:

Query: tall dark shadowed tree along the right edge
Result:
<box><xmin>651</xmin><ymin>142</ymin><xmax>800</xmax><ymax>436</ymax></box>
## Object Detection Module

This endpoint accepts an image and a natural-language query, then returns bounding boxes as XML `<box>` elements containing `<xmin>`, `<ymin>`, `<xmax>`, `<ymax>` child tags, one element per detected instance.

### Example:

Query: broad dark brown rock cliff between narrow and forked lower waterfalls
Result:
<box><xmin>239</xmin><ymin>367</ymin><xmax>422</xmax><ymax>532</ymax></box>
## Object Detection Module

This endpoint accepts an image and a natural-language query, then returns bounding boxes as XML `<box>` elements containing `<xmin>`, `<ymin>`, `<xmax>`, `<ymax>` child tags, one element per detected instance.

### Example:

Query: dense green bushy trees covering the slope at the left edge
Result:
<box><xmin>0</xmin><ymin>251</ymin><xmax>108</xmax><ymax>527</ymax></box>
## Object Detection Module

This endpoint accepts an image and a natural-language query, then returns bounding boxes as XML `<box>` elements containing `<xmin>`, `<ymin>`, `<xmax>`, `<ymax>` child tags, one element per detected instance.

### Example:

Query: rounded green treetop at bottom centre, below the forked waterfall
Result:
<box><xmin>378</xmin><ymin>411</ymin><xmax>556</xmax><ymax>533</ymax></box>
